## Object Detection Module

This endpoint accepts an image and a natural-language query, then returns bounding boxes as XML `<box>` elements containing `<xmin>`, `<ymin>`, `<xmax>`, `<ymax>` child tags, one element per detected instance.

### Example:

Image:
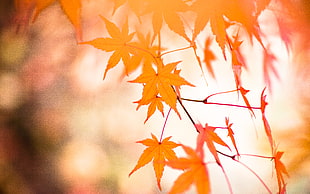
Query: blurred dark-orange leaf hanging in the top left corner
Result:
<box><xmin>15</xmin><ymin>0</ymin><xmax>82</xmax><ymax>41</ymax></box>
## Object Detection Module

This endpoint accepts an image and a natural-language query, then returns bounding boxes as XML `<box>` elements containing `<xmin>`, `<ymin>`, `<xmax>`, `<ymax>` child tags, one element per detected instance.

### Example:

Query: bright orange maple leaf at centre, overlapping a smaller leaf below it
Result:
<box><xmin>130</xmin><ymin>61</ymin><xmax>194</xmax><ymax>119</ymax></box>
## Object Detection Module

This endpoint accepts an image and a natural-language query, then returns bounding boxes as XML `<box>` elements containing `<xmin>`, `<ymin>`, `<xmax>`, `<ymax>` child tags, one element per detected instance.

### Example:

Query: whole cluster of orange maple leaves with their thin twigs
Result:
<box><xmin>15</xmin><ymin>0</ymin><xmax>290</xmax><ymax>193</ymax></box>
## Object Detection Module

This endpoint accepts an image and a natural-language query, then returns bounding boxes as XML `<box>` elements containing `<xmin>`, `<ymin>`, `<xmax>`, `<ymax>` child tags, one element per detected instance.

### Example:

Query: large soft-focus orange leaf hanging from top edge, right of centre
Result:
<box><xmin>191</xmin><ymin>0</ymin><xmax>270</xmax><ymax>59</ymax></box>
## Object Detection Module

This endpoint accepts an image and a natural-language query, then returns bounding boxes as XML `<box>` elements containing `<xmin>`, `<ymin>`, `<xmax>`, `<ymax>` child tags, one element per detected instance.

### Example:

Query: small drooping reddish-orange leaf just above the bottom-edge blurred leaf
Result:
<box><xmin>195</xmin><ymin>123</ymin><xmax>230</xmax><ymax>166</ymax></box>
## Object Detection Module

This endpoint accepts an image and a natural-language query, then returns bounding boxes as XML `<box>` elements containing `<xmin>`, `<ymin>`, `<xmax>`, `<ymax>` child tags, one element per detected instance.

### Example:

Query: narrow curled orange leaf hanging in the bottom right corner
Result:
<box><xmin>274</xmin><ymin>151</ymin><xmax>289</xmax><ymax>193</ymax></box>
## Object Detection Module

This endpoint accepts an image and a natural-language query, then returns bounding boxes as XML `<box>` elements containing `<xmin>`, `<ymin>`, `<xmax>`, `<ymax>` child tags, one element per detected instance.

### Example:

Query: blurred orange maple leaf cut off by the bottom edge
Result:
<box><xmin>166</xmin><ymin>145</ymin><xmax>211</xmax><ymax>194</ymax></box>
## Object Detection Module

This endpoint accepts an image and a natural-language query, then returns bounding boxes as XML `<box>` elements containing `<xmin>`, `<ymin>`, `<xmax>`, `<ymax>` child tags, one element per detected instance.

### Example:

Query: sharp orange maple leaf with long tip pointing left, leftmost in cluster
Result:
<box><xmin>80</xmin><ymin>17</ymin><xmax>136</xmax><ymax>78</ymax></box>
